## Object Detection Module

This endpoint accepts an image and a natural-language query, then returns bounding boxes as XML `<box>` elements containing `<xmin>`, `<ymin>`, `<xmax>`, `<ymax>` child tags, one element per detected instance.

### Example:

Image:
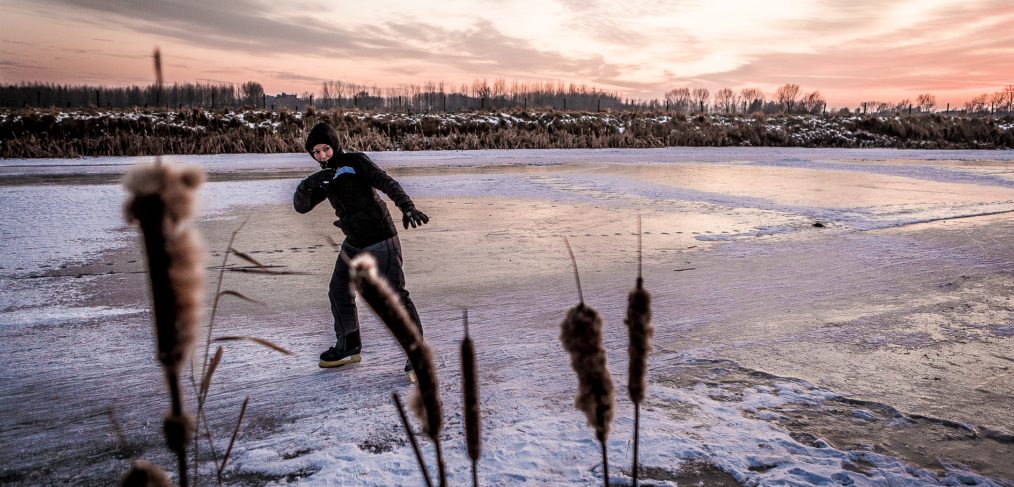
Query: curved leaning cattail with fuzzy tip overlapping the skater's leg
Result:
<box><xmin>350</xmin><ymin>254</ymin><xmax>447</xmax><ymax>486</ymax></box>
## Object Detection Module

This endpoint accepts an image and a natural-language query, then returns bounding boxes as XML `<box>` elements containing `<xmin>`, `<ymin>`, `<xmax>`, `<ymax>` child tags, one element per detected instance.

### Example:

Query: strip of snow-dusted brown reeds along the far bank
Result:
<box><xmin>0</xmin><ymin>108</ymin><xmax>1014</xmax><ymax>158</ymax></box>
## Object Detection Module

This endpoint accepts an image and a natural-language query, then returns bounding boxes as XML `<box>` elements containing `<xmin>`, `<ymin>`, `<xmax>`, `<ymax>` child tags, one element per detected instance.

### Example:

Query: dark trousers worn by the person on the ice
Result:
<box><xmin>328</xmin><ymin>235</ymin><xmax>423</xmax><ymax>342</ymax></box>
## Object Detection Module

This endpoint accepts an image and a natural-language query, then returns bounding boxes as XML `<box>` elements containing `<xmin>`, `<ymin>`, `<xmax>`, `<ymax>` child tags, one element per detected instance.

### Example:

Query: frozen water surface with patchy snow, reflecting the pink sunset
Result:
<box><xmin>0</xmin><ymin>148</ymin><xmax>1014</xmax><ymax>485</ymax></box>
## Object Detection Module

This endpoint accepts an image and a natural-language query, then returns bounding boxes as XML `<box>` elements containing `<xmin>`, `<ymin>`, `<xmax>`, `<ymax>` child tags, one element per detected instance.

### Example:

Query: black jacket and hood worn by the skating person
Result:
<box><xmin>292</xmin><ymin>123</ymin><xmax>415</xmax><ymax>249</ymax></box>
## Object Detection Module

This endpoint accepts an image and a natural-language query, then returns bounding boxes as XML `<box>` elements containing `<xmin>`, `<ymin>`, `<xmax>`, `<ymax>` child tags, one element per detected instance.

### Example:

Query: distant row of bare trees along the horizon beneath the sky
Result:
<box><xmin>0</xmin><ymin>78</ymin><xmax>1014</xmax><ymax>115</ymax></box>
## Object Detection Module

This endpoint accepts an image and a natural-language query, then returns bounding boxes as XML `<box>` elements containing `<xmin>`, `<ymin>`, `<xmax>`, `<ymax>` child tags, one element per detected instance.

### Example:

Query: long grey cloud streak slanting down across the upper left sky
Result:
<box><xmin>27</xmin><ymin>0</ymin><xmax>631</xmax><ymax>80</ymax></box>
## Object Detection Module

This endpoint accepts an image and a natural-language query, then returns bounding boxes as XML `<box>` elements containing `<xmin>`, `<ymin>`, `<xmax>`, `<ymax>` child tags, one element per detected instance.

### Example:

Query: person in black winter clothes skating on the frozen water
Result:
<box><xmin>292</xmin><ymin>122</ymin><xmax>429</xmax><ymax>373</ymax></box>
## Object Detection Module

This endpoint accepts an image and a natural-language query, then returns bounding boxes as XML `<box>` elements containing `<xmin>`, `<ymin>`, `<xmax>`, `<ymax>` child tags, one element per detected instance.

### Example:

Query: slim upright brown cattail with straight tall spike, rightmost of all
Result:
<box><xmin>624</xmin><ymin>215</ymin><xmax>655</xmax><ymax>487</ymax></box>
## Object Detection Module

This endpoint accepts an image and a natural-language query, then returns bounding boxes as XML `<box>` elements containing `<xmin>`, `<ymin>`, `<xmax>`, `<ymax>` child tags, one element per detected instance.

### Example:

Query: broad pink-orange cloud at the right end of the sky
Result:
<box><xmin>648</xmin><ymin>2</ymin><xmax>1014</xmax><ymax>102</ymax></box>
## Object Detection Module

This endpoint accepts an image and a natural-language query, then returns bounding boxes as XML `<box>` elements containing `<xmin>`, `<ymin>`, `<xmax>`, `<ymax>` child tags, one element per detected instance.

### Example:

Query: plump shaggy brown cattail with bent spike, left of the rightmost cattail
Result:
<box><xmin>560</xmin><ymin>237</ymin><xmax>614</xmax><ymax>486</ymax></box>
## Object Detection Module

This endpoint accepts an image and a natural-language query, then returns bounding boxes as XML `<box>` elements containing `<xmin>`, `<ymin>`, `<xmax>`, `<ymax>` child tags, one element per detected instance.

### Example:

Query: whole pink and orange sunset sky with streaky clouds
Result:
<box><xmin>0</xmin><ymin>0</ymin><xmax>1014</xmax><ymax>109</ymax></box>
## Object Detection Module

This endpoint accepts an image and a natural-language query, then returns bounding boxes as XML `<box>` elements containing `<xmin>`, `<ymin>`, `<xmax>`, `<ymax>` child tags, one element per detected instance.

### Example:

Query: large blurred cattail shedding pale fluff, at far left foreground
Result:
<box><xmin>124</xmin><ymin>164</ymin><xmax>204</xmax><ymax>486</ymax></box>
